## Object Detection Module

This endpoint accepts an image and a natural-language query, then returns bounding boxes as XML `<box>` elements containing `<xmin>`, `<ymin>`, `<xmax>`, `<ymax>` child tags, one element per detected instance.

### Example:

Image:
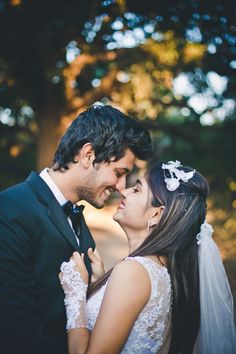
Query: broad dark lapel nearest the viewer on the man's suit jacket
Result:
<box><xmin>26</xmin><ymin>172</ymin><xmax>78</xmax><ymax>250</ymax></box>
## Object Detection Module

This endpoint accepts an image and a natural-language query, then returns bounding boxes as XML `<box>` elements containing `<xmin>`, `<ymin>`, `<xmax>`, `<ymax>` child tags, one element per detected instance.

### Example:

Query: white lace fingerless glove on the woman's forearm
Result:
<box><xmin>61</xmin><ymin>259</ymin><xmax>88</xmax><ymax>331</ymax></box>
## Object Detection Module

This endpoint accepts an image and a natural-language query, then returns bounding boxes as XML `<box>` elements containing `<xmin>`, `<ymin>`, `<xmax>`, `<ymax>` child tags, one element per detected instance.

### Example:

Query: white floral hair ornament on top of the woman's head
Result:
<box><xmin>161</xmin><ymin>160</ymin><xmax>195</xmax><ymax>192</ymax></box>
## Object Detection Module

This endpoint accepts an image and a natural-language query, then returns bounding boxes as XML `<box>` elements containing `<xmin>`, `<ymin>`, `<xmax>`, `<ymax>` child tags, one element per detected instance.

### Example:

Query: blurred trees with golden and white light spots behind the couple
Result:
<box><xmin>0</xmin><ymin>0</ymin><xmax>236</xmax><ymax>286</ymax></box>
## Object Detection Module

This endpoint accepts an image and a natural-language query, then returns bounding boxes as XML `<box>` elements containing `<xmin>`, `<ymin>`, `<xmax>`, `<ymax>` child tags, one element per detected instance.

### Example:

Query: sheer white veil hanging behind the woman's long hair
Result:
<box><xmin>195</xmin><ymin>221</ymin><xmax>236</xmax><ymax>354</ymax></box>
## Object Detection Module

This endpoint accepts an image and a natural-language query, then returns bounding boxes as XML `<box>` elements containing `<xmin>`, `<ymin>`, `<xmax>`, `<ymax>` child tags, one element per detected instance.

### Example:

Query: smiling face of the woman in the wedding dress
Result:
<box><xmin>113</xmin><ymin>177</ymin><xmax>155</xmax><ymax>233</ymax></box>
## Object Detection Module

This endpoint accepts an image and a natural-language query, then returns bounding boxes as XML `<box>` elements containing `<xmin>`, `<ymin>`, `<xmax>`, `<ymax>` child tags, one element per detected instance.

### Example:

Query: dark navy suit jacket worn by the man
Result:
<box><xmin>0</xmin><ymin>172</ymin><xmax>95</xmax><ymax>354</ymax></box>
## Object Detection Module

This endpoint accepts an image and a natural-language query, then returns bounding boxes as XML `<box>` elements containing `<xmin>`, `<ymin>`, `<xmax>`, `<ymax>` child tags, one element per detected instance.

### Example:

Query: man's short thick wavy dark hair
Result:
<box><xmin>53</xmin><ymin>105</ymin><xmax>152</xmax><ymax>170</ymax></box>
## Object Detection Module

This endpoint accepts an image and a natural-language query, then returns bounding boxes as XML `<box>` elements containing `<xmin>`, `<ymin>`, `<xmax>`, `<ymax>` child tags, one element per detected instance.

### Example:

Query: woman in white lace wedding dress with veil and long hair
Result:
<box><xmin>60</xmin><ymin>161</ymin><xmax>236</xmax><ymax>354</ymax></box>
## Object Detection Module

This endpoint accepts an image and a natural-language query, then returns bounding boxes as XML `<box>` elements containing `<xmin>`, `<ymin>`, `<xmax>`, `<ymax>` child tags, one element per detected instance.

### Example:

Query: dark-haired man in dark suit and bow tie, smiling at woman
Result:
<box><xmin>0</xmin><ymin>104</ymin><xmax>152</xmax><ymax>354</ymax></box>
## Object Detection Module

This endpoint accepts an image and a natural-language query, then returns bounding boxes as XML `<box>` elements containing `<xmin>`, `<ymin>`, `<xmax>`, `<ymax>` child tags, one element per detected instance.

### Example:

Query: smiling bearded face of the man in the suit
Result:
<box><xmin>77</xmin><ymin>149</ymin><xmax>135</xmax><ymax>208</ymax></box>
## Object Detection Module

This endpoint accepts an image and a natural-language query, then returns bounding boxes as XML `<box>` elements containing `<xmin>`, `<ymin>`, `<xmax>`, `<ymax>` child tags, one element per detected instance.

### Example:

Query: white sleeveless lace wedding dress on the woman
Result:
<box><xmin>87</xmin><ymin>256</ymin><xmax>171</xmax><ymax>354</ymax></box>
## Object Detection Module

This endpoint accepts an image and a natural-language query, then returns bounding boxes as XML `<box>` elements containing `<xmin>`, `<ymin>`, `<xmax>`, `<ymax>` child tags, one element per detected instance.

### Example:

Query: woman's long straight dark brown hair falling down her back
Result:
<box><xmin>88</xmin><ymin>164</ymin><xmax>208</xmax><ymax>354</ymax></box>
